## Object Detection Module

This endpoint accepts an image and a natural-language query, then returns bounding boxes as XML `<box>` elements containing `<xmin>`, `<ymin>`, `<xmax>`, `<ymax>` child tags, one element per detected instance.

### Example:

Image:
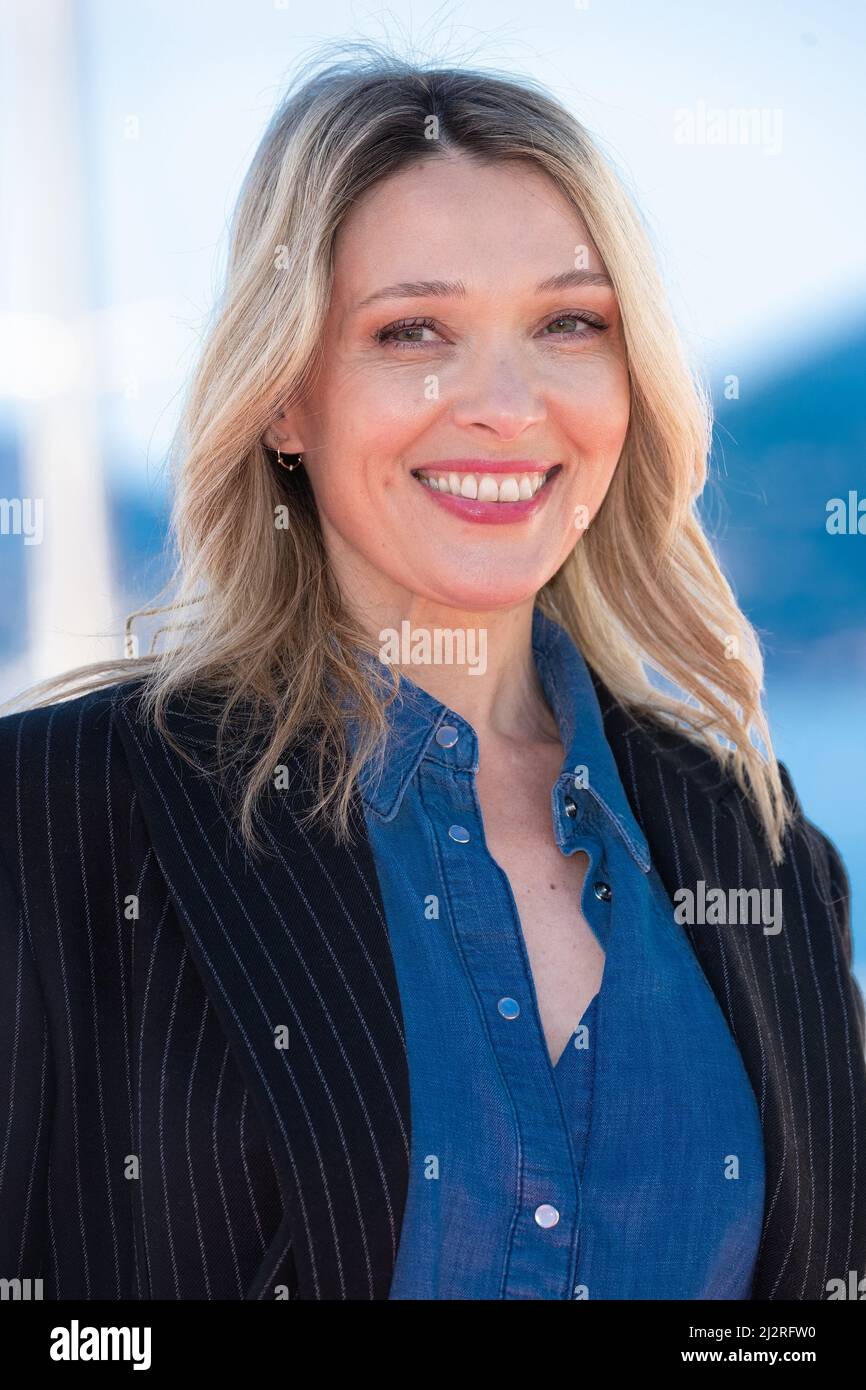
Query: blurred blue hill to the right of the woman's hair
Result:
<box><xmin>702</xmin><ymin>325</ymin><xmax>866</xmax><ymax>676</ymax></box>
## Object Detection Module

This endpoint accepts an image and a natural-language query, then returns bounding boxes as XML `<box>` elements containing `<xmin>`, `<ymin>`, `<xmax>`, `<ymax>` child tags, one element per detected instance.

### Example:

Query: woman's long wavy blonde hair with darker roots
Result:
<box><xmin>6</xmin><ymin>43</ymin><xmax>791</xmax><ymax>862</ymax></box>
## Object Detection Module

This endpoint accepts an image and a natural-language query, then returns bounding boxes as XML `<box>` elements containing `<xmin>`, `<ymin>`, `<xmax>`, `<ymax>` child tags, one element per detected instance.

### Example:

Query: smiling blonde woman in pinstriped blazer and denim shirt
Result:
<box><xmin>0</xmin><ymin>50</ymin><xmax>866</xmax><ymax>1300</ymax></box>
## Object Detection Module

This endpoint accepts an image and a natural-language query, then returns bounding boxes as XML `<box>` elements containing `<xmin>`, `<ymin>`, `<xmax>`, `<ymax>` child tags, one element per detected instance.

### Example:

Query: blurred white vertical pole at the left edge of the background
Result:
<box><xmin>1</xmin><ymin>0</ymin><xmax>122</xmax><ymax>680</ymax></box>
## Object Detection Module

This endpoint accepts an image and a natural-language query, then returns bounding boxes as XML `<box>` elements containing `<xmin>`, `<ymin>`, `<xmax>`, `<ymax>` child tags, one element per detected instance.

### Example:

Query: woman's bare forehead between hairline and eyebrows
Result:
<box><xmin>334</xmin><ymin>153</ymin><xmax>605</xmax><ymax>297</ymax></box>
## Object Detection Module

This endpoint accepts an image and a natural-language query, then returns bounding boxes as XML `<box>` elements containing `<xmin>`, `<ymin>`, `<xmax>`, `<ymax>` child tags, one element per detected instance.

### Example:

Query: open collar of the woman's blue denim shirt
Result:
<box><xmin>348</xmin><ymin>606</ymin><xmax>651</xmax><ymax>873</ymax></box>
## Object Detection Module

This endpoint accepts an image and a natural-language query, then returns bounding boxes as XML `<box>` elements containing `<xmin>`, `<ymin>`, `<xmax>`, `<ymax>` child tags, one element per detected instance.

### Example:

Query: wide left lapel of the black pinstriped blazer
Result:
<box><xmin>114</xmin><ymin>682</ymin><xmax>410</xmax><ymax>1300</ymax></box>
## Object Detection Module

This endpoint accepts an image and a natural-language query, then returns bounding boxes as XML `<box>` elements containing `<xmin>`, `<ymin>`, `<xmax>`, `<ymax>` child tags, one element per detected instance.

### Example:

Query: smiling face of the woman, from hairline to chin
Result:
<box><xmin>265</xmin><ymin>154</ymin><xmax>628</xmax><ymax>616</ymax></box>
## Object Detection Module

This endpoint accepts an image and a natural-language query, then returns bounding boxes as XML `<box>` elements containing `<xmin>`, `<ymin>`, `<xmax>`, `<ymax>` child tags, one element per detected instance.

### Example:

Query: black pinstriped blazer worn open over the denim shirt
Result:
<box><xmin>0</xmin><ymin>681</ymin><xmax>866</xmax><ymax>1300</ymax></box>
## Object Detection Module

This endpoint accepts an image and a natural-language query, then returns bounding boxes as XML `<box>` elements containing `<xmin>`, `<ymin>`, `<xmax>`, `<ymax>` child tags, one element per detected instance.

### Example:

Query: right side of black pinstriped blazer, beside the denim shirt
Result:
<box><xmin>594</xmin><ymin>677</ymin><xmax>866</xmax><ymax>1300</ymax></box>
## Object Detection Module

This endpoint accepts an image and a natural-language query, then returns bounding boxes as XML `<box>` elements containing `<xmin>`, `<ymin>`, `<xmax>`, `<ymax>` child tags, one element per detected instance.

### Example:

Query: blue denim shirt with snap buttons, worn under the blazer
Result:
<box><xmin>349</xmin><ymin>607</ymin><xmax>765</xmax><ymax>1300</ymax></box>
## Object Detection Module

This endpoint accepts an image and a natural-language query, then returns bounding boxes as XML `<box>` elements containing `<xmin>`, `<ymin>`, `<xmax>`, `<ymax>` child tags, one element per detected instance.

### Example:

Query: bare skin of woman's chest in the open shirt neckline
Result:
<box><xmin>475</xmin><ymin>745</ymin><xmax>605</xmax><ymax>1065</ymax></box>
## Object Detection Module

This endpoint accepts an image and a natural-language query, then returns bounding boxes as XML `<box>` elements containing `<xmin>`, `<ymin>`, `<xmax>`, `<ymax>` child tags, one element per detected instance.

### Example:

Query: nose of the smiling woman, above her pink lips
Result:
<box><xmin>452</xmin><ymin>348</ymin><xmax>546</xmax><ymax>441</ymax></box>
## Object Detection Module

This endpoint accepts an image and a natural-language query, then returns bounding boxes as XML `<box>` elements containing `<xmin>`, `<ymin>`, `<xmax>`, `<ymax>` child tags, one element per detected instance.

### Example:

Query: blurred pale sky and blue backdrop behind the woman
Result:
<box><xmin>0</xmin><ymin>0</ymin><xmax>866</xmax><ymax>983</ymax></box>
